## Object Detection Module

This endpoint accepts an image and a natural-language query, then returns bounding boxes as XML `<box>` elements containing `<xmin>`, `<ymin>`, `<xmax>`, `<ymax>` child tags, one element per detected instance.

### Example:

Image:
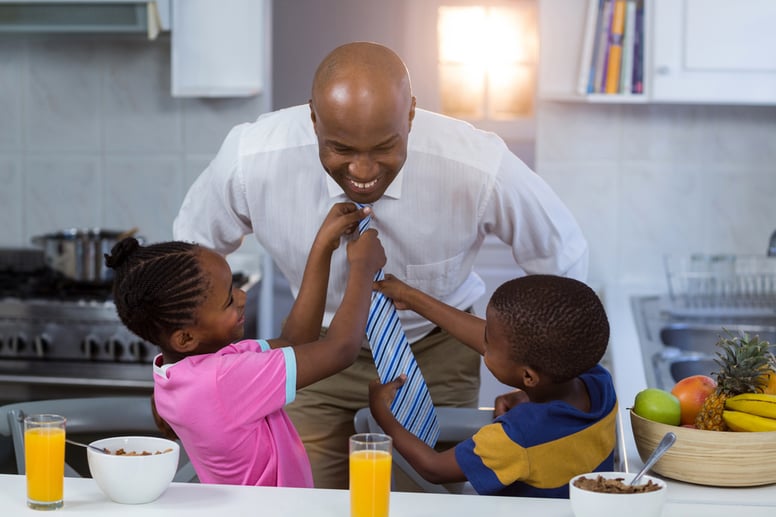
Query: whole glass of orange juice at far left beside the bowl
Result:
<box><xmin>24</xmin><ymin>415</ymin><xmax>65</xmax><ymax>510</ymax></box>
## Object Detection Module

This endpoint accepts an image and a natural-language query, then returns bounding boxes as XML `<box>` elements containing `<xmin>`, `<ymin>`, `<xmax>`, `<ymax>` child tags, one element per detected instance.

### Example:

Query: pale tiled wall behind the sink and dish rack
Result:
<box><xmin>536</xmin><ymin>102</ymin><xmax>776</xmax><ymax>291</ymax></box>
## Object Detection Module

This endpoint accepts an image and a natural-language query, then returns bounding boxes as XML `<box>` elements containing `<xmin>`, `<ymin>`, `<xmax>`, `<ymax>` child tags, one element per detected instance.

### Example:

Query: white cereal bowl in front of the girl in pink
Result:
<box><xmin>86</xmin><ymin>436</ymin><xmax>180</xmax><ymax>504</ymax></box>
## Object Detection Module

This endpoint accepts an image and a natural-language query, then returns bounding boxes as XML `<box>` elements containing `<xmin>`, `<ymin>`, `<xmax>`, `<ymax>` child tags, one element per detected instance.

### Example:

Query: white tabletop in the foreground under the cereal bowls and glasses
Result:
<box><xmin>0</xmin><ymin>474</ymin><xmax>776</xmax><ymax>517</ymax></box>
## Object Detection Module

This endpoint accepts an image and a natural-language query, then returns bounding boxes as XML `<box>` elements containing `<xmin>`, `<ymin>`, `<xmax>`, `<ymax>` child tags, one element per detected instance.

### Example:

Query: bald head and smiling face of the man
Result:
<box><xmin>310</xmin><ymin>43</ymin><xmax>415</xmax><ymax>203</ymax></box>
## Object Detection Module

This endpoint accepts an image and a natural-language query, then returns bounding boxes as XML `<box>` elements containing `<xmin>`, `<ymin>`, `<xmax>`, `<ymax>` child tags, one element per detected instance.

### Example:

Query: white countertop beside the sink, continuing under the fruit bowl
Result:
<box><xmin>604</xmin><ymin>285</ymin><xmax>776</xmax><ymax>504</ymax></box>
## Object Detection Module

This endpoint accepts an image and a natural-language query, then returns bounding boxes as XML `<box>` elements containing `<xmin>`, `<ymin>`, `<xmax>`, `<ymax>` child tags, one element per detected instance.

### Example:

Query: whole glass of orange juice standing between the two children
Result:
<box><xmin>350</xmin><ymin>433</ymin><xmax>392</xmax><ymax>517</ymax></box>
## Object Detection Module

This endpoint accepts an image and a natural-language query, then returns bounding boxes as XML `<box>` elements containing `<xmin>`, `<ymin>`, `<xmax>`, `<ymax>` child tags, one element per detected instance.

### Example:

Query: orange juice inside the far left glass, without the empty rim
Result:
<box><xmin>24</xmin><ymin>427</ymin><xmax>65</xmax><ymax>505</ymax></box>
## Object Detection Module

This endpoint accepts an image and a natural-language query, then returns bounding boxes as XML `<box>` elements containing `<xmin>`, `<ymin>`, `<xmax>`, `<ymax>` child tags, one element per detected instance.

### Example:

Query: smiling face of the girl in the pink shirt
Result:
<box><xmin>187</xmin><ymin>249</ymin><xmax>246</xmax><ymax>354</ymax></box>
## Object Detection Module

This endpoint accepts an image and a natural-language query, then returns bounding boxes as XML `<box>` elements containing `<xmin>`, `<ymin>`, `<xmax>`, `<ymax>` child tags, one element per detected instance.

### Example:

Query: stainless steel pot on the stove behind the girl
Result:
<box><xmin>31</xmin><ymin>228</ymin><xmax>136</xmax><ymax>283</ymax></box>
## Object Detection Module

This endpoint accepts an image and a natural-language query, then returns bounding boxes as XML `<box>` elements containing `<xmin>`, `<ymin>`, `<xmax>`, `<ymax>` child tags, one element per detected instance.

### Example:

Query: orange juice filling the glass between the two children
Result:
<box><xmin>350</xmin><ymin>450</ymin><xmax>391</xmax><ymax>517</ymax></box>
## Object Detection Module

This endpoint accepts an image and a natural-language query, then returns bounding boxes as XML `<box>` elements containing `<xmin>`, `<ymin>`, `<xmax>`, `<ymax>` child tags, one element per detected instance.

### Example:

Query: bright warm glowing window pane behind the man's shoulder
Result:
<box><xmin>437</xmin><ymin>2</ymin><xmax>538</xmax><ymax>120</ymax></box>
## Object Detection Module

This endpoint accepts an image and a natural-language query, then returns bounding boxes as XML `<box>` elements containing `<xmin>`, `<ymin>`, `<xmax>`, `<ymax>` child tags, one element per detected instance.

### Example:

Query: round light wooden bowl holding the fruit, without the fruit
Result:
<box><xmin>630</xmin><ymin>410</ymin><xmax>776</xmax><ymax>487</ymax></box>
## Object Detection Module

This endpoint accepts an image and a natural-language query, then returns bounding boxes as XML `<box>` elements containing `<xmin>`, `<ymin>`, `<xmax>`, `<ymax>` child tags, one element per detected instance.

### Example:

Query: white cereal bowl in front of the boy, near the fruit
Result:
<box><xmin>569</xmin><ymin>472</ymin><xmax>667</xmax><ymax>517</ymax></box>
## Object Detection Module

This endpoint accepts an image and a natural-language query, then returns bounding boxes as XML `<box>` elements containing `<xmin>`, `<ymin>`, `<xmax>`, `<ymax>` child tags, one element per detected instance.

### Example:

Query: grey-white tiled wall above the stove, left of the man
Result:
<box><xmin>0</xmin><ymin>35</ymin><xmax>268</xmax><ymax>247</ymax></box>
